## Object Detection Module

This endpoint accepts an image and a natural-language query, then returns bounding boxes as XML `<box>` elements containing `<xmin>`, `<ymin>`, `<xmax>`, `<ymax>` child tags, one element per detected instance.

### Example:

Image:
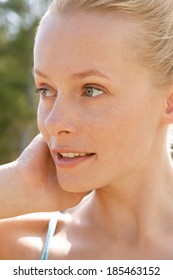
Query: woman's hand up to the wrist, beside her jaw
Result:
<box><xmin>14</xmin><ymin>134</ymin><xmax>85</xmax><ymax>212</ymax></box>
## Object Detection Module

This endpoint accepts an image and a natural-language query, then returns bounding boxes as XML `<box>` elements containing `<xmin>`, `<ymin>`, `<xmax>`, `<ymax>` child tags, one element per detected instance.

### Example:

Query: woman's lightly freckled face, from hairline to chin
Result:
<box><xmin>34</xmin><ymin>13</ymin><xmax>163</xmax><ymax>191</ymax></box>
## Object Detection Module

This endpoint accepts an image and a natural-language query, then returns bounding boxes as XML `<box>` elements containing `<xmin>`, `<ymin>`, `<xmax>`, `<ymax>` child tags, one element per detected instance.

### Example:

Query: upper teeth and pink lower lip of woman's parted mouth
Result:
<box><xmin>55</xmin><ymin>152</ymin><xmax>96</xmax><ymax>168</ymax></box>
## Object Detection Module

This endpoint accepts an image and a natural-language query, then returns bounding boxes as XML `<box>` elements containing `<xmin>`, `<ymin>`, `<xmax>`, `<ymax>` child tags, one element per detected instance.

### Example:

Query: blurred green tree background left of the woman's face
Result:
<box><xmin>0</xmin><ymin>0</ymin><xmax>49</xmax><ymax>164</ymax></box>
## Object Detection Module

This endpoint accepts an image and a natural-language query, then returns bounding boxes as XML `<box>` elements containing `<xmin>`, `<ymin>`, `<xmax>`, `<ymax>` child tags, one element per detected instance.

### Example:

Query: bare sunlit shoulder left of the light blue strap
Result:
<box><xmin>0</xmin><ymin>213</ymin><xmax>55</xmax><ymax>260</ymax></box>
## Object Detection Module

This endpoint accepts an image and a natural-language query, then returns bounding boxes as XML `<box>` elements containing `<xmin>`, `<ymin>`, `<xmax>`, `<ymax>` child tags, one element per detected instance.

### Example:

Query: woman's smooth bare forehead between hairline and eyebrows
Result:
<box><xmin>34</xmin><ymin>13</ymin><xmax>139</xmax><ymax>77</ymax></box>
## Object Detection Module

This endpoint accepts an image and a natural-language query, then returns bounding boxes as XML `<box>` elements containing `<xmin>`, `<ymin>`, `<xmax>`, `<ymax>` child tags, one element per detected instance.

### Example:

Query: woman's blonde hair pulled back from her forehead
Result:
<box><xmin>45</xmin><ymin>0</ymin><xmax>173</xmax><ymax>87</ymax></box>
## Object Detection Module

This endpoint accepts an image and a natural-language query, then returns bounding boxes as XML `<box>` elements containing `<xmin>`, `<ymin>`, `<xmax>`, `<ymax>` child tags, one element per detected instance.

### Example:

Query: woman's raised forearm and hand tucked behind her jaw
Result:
<box><xmin>0</xmin><ymin>134</ymin><xmax>85</xmax><ymax>219</ymax></box>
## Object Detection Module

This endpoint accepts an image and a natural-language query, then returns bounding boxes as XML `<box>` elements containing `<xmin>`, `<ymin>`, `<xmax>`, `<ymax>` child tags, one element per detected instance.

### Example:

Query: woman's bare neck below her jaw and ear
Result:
<box><xmin>88</xmin><ymin>141</ymin><xmax>173</xmax><ymax>242</ymax></box>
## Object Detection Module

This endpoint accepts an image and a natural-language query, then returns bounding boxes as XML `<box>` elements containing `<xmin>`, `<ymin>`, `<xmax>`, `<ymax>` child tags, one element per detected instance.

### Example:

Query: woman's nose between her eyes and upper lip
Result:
<box><xmin>45</xmin><ymin>97</ymin><xmax>77</xmax><ymax>136</ymax></box>
